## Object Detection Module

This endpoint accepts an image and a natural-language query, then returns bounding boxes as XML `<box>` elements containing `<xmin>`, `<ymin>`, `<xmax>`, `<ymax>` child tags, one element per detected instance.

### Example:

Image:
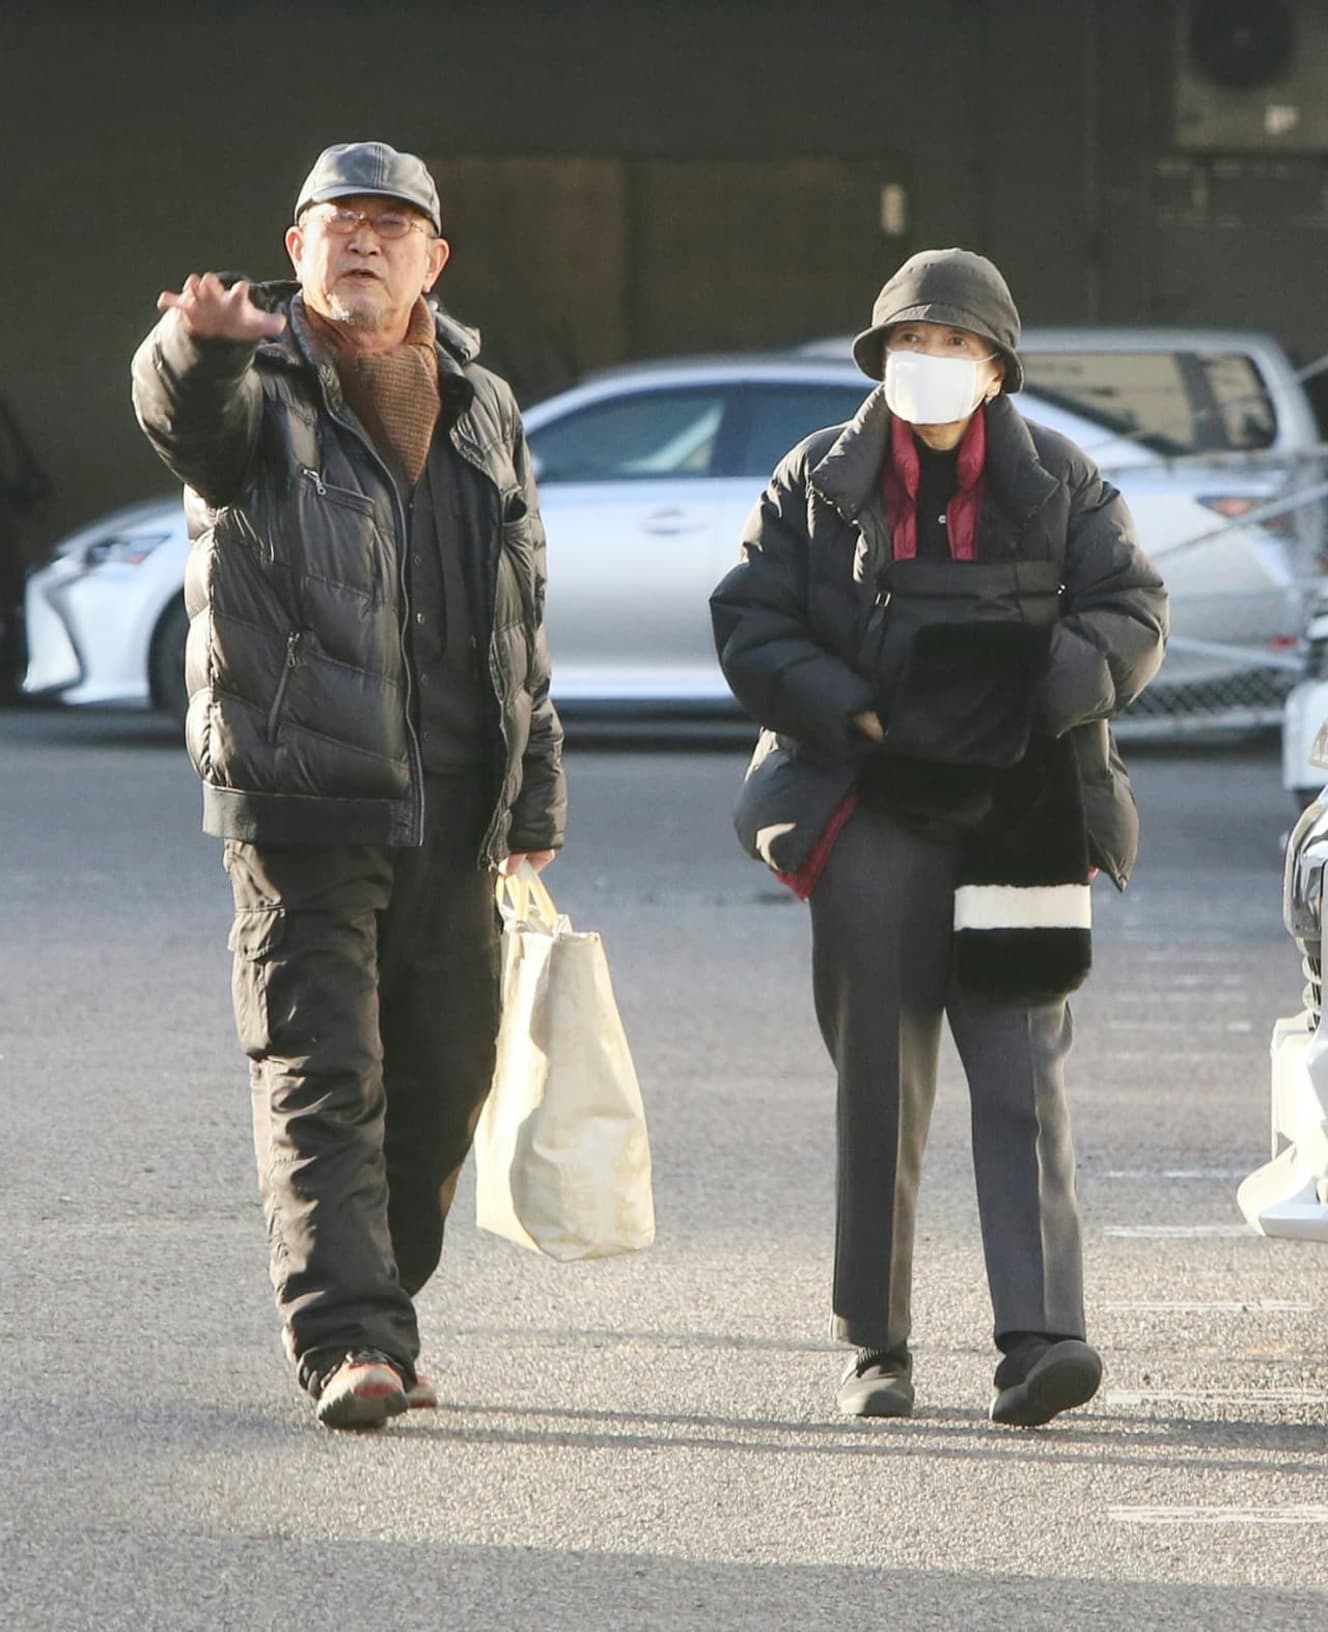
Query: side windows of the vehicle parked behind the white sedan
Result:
<box><xmin>1023</xmin><ymin>351</ymin><xmax>1277</xmax><ymax>457</ymax></box>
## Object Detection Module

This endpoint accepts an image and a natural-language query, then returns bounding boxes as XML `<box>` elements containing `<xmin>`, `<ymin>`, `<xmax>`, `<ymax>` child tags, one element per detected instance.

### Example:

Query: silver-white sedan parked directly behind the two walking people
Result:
<box><xmin>26</xmin><ymin>353</ymin><xmax>1302</xmax><ymax>725</ymax></box>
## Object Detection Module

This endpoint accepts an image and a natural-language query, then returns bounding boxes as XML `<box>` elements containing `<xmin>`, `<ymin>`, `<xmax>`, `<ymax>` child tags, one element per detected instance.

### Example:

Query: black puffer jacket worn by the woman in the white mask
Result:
<box><xmin>711</xmin><ymin>390</ymin><xmax>1168</xmax><ymax>888</ymax></box>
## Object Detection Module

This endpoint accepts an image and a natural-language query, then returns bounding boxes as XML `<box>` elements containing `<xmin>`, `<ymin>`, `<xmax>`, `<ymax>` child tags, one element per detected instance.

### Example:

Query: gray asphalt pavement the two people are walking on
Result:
<box><xmin>0</xmin><ymin>710</ymin><xmax>1328</xmax><ymax>1632</ymax></box>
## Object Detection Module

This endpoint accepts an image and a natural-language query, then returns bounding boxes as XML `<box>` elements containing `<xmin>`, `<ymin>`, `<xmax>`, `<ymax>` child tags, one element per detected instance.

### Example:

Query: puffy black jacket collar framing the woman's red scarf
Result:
<box><xmin>811</xmin><ymin>385</ymin><xmax>1059</xmax><ymax>526</ymax></box>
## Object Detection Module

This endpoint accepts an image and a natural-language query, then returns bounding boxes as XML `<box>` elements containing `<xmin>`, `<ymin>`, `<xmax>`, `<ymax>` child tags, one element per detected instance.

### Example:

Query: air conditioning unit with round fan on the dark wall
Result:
<box><xmin>1175</xmin><ymin>0</ymin><xmax>1328</xmax><ymax>153</ymax></box>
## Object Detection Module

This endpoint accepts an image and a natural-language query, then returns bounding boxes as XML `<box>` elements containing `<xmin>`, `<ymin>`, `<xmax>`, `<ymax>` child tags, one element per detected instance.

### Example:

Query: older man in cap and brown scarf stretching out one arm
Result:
<box><xmin>134</xmin><ymin>142</ymin><xmax>566</xmax><ymax>1428</ymax></box>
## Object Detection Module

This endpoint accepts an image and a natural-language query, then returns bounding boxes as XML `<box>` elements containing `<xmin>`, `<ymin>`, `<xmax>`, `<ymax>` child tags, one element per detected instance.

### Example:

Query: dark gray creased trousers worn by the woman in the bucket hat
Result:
<box><xmin>811</xmin><ymin>808</ymin><xmax>1085</xmax><ymax>1348</ymax></box>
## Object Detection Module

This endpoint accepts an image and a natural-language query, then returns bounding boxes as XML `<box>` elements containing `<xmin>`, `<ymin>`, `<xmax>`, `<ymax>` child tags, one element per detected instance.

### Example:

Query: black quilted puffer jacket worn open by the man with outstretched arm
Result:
<box><xmin>134</xmin><ymin>284</ymin><xmax>566</xmax><ymax>862</ymax></box>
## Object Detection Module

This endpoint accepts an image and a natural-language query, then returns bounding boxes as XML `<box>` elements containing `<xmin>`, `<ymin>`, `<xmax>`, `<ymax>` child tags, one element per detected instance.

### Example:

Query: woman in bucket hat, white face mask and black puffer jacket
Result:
<box><xmin>711</xmin><ymin>250</ymin><xmax>1166</xmax><ymax>1426</ymax></box>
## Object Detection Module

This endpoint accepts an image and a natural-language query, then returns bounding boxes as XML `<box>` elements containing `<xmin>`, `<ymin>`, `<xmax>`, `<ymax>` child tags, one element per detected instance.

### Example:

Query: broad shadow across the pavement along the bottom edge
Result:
<box><xmin>10</xmin><ymin>1534</ymin><xmax>1328</xmax><ymax>1632</ymax></box>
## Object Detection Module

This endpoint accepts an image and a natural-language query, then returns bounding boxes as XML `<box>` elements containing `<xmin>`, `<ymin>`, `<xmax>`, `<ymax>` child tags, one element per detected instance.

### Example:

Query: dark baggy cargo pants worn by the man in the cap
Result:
<box><xmin>225</xmin><ymin>775</ymin><xmax>499</xmax><ymax>1389</ymax></box>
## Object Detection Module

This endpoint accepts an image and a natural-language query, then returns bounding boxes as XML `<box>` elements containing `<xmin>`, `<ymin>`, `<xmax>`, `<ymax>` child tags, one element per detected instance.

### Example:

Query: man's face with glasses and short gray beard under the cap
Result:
<box><xmin>286</xmin><ymin>194</ymin><xmax>447</xmax><ymax>333</ymax></box>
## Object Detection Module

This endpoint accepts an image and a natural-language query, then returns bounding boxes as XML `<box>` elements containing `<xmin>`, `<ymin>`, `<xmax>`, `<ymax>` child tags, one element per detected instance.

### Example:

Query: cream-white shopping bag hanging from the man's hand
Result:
<box><xmin>475</xmin><ymin>867</ymin><xmax>654</xmax><ymax>1260</ymax></box>
